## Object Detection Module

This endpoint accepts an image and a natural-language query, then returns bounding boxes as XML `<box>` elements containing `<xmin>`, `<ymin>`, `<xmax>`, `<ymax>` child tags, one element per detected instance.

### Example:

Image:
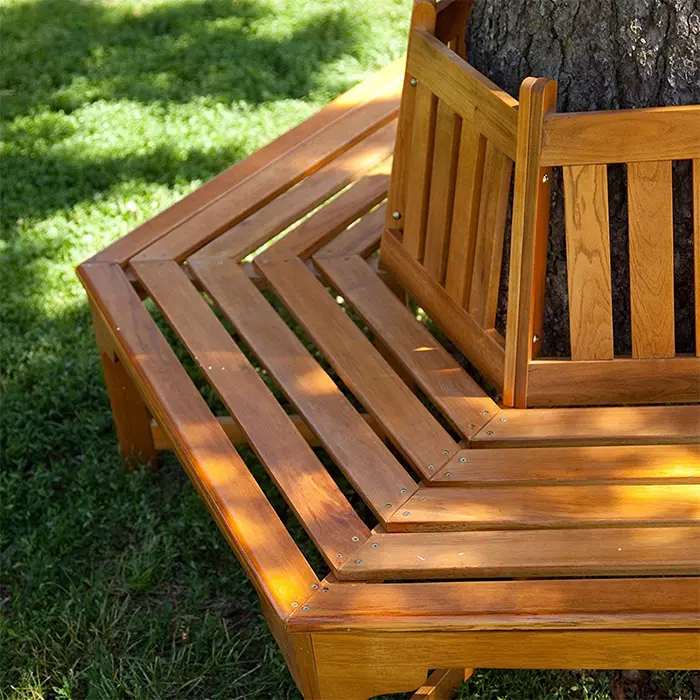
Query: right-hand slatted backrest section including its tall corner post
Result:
<box><xmin>506</xmin><ymin>89</ymin><xmax>700</xmax><ymax>406</ymax></box>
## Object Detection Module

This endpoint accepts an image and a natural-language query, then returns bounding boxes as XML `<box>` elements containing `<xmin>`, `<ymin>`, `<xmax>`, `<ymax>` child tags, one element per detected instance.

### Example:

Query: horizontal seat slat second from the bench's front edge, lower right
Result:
<box><xmin>338</xmin><ymin>527</ymin><xmax>700</xmax><ymax>581</ymax></box>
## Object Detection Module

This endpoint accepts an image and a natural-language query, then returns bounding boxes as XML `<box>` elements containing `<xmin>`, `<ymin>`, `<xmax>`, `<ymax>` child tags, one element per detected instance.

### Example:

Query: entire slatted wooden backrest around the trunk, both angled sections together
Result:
<box><xmin>381</xmin><ymin>0</ymin><xmax>700</xmax><ymax>407</ymax></box>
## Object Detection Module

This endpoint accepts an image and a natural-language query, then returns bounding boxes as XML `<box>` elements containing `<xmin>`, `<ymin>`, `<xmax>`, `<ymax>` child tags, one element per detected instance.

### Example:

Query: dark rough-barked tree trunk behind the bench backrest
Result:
<box><xmin>468</xmin><ymin>0</ymin><xmax>700</xmax><ymax>356</ymax></box>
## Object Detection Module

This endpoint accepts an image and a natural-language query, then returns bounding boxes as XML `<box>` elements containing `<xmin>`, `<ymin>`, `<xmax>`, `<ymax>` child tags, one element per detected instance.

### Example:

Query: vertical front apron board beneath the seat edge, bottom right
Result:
<box><xmin>312</xmin><ymin>628</ymin><xmax>700</xmax><ymax>680</ymax></box>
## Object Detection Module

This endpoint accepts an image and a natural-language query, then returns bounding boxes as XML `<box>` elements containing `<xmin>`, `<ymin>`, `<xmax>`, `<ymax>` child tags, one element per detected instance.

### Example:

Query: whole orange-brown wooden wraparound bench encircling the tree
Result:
<box><xmin>79</xmin><ymin>0</ymin><xmax>700</xmax><ymax>700</ymax></box>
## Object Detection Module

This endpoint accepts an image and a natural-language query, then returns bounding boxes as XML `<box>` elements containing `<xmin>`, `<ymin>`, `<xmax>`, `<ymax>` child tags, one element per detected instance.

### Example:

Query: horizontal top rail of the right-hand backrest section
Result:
<box><xmin>542</xmin><ymin>105</ymin><xmax>700</xmax><ymax>166</ymax></box>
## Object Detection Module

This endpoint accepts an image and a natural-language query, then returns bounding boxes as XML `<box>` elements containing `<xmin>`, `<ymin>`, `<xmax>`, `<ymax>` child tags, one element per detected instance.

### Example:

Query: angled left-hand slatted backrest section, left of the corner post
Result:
<box><xmin>382</xmin><ymin>0</ymin><xmax>518</xmax><ymax>389</ymax></box>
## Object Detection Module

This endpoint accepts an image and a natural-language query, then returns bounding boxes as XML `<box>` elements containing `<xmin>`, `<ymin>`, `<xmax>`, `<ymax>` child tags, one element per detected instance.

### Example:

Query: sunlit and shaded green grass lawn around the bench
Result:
<box><xmin>0</xmin><ymin>0</ymin><xmax>692</xmax><ymax>700</ymax></box>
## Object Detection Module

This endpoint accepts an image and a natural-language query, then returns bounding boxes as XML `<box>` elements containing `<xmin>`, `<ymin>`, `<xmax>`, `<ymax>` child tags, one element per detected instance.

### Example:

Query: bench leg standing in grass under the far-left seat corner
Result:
<box><xmin>92</xmin><ymin>302</ymin><xmax>159</xmax><ymax>469</ymax></box>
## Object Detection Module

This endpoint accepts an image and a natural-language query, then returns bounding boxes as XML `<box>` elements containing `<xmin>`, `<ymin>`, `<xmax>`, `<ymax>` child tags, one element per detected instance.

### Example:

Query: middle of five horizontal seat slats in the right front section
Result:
<box><xmin>387</xmin><ymin>484</ymin><xmax>700</xmax><ymax>532</ymax></box>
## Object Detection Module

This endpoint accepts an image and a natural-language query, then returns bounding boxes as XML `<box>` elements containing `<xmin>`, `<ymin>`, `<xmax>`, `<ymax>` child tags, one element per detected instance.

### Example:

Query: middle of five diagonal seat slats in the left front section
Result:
<box><xmin>187</xmin><ymin>261</ymin><xmax>416</xmax><ymax>521</ymax></box>
